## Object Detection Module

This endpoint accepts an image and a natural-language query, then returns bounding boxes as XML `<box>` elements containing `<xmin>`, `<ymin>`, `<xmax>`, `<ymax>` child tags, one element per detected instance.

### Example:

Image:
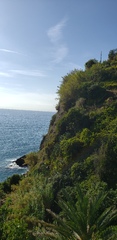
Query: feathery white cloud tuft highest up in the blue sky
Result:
<box><xmin>47</xmin><ymin>19</ymin><xmax>66</xmax><ymax>43</ymax></box>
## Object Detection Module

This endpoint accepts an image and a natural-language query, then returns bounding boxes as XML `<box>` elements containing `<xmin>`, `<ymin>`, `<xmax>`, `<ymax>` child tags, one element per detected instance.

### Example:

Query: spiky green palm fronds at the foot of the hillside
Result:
<box><xmin>35</xmin><ymin>187</ymin><xmax>117</xmax><ymax>240</ymax></box>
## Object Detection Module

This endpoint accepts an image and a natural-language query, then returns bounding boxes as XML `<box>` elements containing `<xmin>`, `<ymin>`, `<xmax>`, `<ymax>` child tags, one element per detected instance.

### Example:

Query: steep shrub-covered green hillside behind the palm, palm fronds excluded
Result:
<box><xmin>0</xmin><ymin>51</ymin><xmax>117</xmax><ymax>240</ymax></box>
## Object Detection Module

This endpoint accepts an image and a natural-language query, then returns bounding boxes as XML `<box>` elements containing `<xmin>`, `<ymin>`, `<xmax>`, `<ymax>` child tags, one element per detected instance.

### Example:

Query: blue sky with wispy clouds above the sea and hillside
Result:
<box><xmin>0</xmin><ymin>0</ymin><xmax>117</xmax><ymax>112</ymax></box>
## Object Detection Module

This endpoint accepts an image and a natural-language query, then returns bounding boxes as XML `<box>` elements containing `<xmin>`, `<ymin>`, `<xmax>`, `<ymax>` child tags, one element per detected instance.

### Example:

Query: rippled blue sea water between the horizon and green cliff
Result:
<box><xmin>0</xmin><ymin>109</ymin><xmax>54</xmax><ymax>182</ymax></box>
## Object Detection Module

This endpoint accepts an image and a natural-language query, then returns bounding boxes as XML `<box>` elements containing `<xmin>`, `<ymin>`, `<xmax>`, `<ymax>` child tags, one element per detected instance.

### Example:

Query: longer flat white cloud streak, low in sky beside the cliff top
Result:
<box><xmin>10</xmin><ymin>69</ymin><xmax>46</xmax><ymax>77</ymax></box>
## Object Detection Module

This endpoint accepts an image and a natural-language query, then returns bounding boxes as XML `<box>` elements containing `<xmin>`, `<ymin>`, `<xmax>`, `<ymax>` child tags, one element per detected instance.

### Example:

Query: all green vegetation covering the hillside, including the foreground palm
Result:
<box><xmin>0</xmin><ymin>49</ymin><xmax>117</xmax><ymax>240</ymax></box>
